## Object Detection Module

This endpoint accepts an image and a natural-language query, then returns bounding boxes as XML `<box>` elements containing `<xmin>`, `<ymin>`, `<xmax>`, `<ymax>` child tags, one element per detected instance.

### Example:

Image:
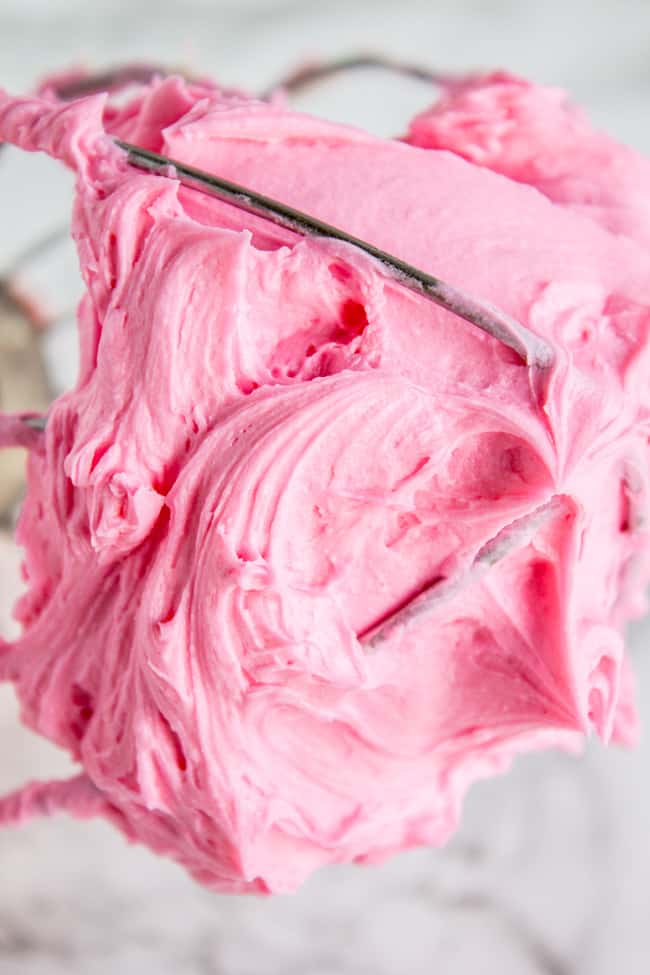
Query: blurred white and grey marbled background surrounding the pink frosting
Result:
<box><xmin>0</xmin><ymin>0</ymin><xmax>650</xmax><ymax>975</ymax></box>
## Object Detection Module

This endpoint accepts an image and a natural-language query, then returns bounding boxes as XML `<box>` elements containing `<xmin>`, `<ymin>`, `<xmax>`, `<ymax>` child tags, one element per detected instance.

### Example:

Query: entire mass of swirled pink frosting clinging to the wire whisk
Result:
<box><xmin>0</xmin><ymin>70</ymin><xmax>650</xmax><ymax>892</ymax></box>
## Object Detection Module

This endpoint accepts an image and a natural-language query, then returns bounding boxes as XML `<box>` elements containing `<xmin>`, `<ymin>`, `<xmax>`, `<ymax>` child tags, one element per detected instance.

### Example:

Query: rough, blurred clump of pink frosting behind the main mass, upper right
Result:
<box><xmin>406</xmin><ymin>71</ymin><xmax>650</xmax><ymax>246</ymax></box>
